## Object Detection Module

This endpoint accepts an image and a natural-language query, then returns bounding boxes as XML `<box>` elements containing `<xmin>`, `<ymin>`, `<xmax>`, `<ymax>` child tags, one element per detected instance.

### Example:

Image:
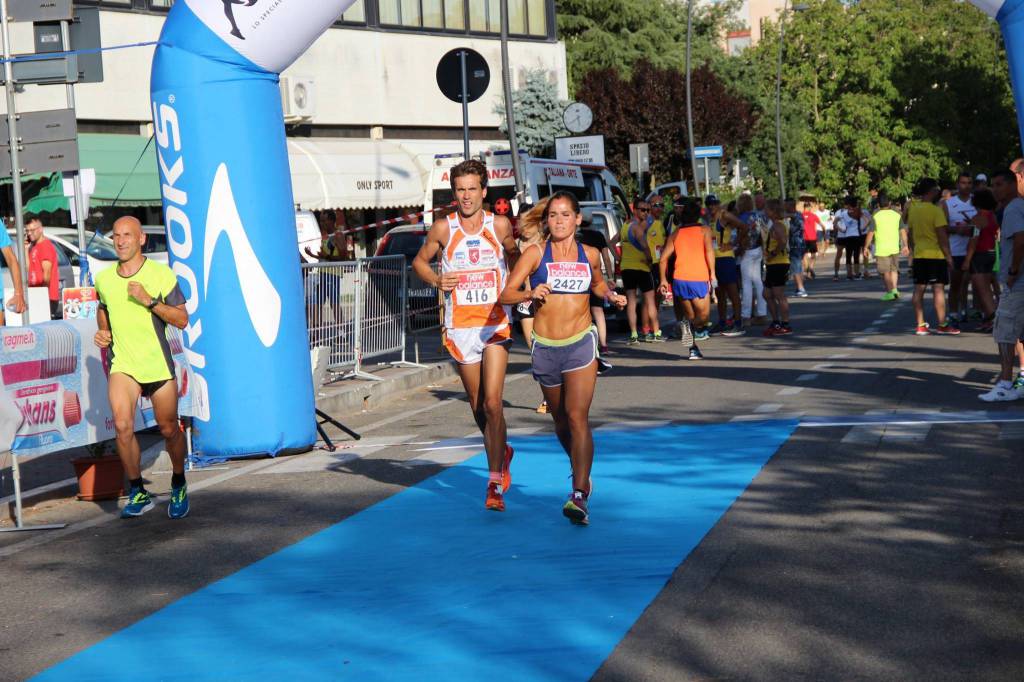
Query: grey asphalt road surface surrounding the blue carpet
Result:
<box><xmin>0</xmin><ymin>280</ymin><xmax>1024</xmax><ymax>681</ymax></box>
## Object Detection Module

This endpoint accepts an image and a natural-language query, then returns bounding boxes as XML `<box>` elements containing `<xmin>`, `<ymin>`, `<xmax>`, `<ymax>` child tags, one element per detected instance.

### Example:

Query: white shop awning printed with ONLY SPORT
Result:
<box><xmin>288</xmin><ymin>137</ymin><xmax>426</xmax><ymax>210</ymax></box>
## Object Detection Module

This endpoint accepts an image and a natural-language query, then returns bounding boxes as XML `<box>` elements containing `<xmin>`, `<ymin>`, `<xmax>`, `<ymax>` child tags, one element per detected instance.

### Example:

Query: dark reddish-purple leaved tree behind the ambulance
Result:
<box><xmin>577</xmin><ymin>60</ymin><xmax>755</xmax><ymax>192</ymax></box>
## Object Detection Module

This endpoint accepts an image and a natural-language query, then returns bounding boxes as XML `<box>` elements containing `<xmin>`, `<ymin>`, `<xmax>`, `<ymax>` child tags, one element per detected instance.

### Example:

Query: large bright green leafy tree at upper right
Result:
<box><xmin>719</xmin><ymin>0</ymin><xmax>1019</xmax><ymax>199</ymax></box>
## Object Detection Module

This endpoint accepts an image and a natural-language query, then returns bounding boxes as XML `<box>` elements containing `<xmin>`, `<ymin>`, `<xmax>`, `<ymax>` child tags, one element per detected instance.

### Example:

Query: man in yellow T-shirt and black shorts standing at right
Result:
<box><xmin>905</xmin><ymin>177</ymin><xmax>959</xmax><ymax>336</ymax></box>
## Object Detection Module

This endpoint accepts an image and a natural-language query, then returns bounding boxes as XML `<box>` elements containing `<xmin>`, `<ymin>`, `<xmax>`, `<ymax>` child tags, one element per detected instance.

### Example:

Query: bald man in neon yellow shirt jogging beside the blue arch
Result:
<box><xmin>94</xmin><ymin>216</ymin><xmax>188</xmax><ymax>518</ymax></box>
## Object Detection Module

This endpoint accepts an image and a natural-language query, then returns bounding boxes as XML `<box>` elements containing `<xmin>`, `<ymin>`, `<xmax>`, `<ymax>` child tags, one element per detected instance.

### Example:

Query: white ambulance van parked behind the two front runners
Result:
<box><xmin>424</xmin><ymin>151</ymin><xmax>630</xmax><ymax>224</ymax></box>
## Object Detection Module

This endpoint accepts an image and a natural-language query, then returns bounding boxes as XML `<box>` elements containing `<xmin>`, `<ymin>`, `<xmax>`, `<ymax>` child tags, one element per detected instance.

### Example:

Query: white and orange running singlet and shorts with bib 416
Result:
<box><xmin>441</xmin><ymin>212</ymin><xmax>512</xmax><ymax>365</ymax></box>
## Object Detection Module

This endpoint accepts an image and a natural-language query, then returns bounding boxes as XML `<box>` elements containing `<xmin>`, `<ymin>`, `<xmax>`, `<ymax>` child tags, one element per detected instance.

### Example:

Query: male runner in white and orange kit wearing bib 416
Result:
<box><xmin>413</xmin><ymin>160</ymin><xmax>519</xmax><ymax>511</ymax></box>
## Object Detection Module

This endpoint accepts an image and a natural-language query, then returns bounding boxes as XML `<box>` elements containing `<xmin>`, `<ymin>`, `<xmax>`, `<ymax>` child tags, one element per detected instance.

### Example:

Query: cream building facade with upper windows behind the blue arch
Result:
<box><xmin>0</xmin><ymin>0</ymin><xmax>567</xmax><ymax>241</ymax></box>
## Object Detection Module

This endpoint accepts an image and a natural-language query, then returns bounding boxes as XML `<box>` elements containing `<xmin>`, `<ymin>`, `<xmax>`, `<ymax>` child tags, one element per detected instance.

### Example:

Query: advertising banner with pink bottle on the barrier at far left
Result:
<box><xmin>0</xmin><ymin>319</ymin><xmax>191</xmax><ymax>457</ymax></box>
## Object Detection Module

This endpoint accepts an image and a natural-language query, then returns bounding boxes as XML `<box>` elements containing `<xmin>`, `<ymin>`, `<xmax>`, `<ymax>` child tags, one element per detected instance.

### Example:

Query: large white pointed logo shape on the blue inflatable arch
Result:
<box><xmin>203</xmin><ymin>164</ymin><xmax>281</xmax><ymax>348</ymax></box>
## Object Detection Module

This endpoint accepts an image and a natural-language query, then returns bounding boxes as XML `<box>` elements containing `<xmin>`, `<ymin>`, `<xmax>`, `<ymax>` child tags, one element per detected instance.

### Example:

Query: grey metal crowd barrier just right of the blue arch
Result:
<box><xmin>302</xmin><ymin>255</ymin><xmax>430</xmax><ymax>381</ymax></box>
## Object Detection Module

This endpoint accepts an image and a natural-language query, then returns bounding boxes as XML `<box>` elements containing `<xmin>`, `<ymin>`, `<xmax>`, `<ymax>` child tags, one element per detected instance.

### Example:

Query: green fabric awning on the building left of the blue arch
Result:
<box><xmin>25</xmin><ymin>133</ymin><xmax>161</xmax><ymax>213</ymax></box>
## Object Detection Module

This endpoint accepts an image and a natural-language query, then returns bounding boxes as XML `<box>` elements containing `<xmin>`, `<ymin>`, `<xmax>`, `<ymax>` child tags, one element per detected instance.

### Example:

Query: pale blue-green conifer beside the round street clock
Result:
<box><xmin>494</xmin><ymin>69</ymin><xmax>568</xmax><ymax>157</ymax></box>
